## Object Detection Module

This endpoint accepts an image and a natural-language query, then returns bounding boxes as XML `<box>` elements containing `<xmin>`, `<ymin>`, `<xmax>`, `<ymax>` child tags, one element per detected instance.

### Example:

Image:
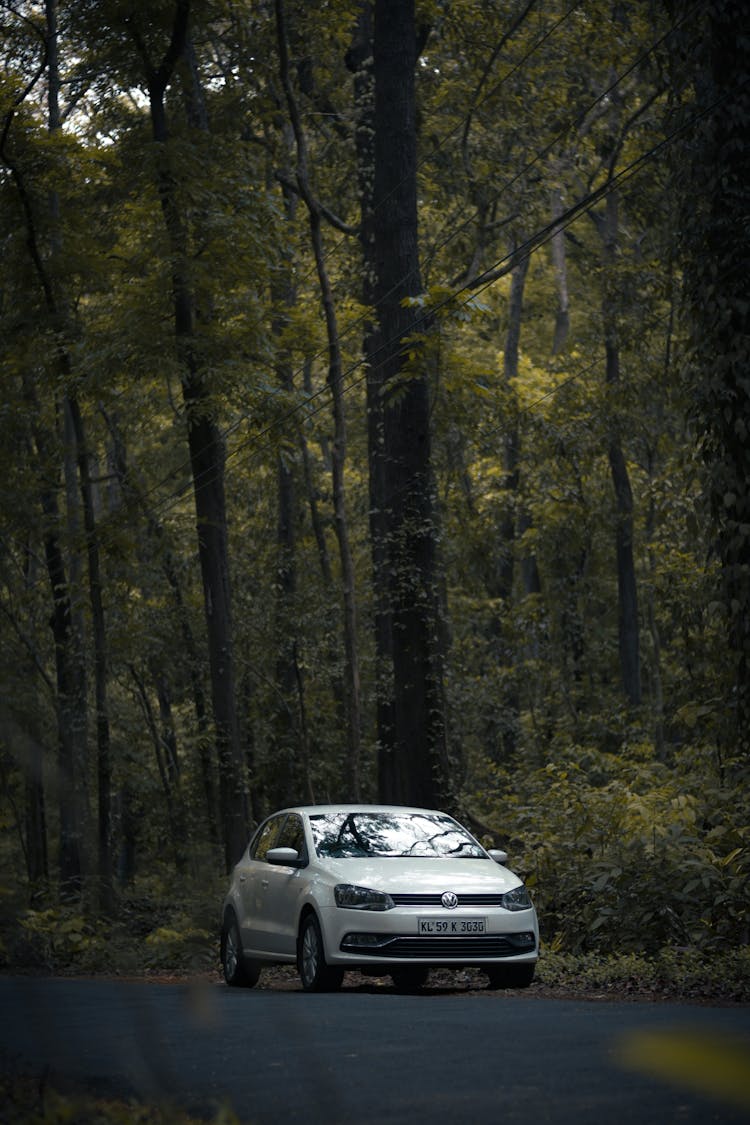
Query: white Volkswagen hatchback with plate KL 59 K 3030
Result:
<box><xmin>220</xmin><ymin>804</ymin><xmax>539</xmax><ymax>991</ymax></box>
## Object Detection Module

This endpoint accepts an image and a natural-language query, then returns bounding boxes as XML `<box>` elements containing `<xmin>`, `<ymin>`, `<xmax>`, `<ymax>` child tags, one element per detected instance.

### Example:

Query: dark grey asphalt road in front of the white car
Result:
<box><xmin>0</xmin><ymin>978</ymin><xmax>750</xmax><ymax>1125</ymax></box>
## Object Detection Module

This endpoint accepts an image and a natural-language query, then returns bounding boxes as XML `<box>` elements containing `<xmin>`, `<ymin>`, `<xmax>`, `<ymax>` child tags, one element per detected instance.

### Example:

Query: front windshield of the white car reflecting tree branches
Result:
<box><xmin>310</xmin><ymin>812</ymin><xmax>486</xmax><ymax>860</ymax></box>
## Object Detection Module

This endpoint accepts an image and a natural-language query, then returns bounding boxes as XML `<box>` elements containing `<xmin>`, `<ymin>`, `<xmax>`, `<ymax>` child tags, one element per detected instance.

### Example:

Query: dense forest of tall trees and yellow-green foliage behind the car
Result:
<box><xmin>0</xmin><ymin>0</ymin><xmax>750</xmax><ymax>989</ymax></box>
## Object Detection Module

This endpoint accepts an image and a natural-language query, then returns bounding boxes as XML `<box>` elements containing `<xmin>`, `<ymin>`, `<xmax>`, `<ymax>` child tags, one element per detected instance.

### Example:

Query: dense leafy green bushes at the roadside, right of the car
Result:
<box><xmin>477</xmin><ymin>743</ymin><xmax>750</xmax><ymax>955</ymax></box>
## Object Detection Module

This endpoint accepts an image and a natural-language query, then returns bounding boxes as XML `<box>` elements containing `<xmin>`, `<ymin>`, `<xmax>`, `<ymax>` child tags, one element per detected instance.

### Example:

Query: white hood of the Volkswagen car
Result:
<box><xmin>318</xmin><ymin>858</ymin><xmax>522</xmax><ymax>894</ymax></box>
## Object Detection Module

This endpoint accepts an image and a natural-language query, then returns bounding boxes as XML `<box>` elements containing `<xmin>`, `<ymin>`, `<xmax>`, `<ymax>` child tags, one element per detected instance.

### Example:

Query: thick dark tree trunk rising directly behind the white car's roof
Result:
<box><xmin>373</xmin><ymin>0</ymin><xmax>451</xmax><ymax>804</ymax></box>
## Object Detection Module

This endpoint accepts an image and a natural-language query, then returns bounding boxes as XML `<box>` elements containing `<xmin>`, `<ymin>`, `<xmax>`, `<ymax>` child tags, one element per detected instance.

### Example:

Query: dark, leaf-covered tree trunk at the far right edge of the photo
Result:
<box><xmin>668</xmin><ymin>0</ymin><xmax>750</xmax><ymax>763</ymax></box>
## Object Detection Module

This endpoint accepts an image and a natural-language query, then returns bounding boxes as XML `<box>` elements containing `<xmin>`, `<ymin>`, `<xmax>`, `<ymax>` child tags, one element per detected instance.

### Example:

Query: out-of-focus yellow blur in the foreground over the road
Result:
<box><xmin>620</xmin><ymin>1029</ymin><xmax>750</xmax><ymax>1109</ymax></box>
